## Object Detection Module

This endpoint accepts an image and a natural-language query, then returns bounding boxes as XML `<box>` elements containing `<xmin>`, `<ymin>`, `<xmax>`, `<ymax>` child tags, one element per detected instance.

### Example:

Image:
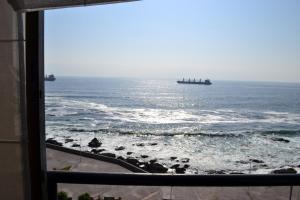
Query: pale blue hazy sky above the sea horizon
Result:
<box><xmin>45</xmin><ymin>0</ymin><xmax>300</xmax><ymax>82</ymax></box>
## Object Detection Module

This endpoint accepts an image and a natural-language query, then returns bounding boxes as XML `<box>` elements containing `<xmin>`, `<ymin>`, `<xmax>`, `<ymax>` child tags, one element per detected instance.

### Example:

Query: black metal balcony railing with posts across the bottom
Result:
<box><xmin>47</xmin><ymin>171</ymin><xmax>300</xmax><ymax>200</ymax></box>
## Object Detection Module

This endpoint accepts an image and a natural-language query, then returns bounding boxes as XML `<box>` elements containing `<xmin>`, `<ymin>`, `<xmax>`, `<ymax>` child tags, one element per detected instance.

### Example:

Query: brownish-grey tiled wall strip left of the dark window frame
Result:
<box><xmin>0</xmin><ymin>0</ymin><xmax>28</xmax><ymax>199</ymax></box>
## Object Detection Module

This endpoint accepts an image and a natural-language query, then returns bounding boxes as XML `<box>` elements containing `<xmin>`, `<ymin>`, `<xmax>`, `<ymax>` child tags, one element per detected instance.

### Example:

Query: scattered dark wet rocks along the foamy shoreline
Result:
<box><xmin>46</xmin><ymin>138</ymin><xmax>300</xmax><ymax>175</ymax></box>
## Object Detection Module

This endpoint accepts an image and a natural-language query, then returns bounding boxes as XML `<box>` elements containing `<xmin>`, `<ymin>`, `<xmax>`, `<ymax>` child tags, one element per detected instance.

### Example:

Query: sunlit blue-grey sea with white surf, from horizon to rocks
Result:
<box><xmin>45</xmin><ymin>77</ymin><xmax>300</xmax><ymax>174</ymax></box>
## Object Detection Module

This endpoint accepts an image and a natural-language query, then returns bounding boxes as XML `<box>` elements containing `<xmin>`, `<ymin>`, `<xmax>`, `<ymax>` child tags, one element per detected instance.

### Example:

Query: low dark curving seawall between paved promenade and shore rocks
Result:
<box><xmin>46</xmin><ymin>143</ymin><xmax>149</xmax><ymax>173</ymax></box>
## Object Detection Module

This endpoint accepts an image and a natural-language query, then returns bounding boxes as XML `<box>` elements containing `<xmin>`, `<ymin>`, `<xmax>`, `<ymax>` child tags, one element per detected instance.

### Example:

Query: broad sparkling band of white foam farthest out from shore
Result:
<box><xmin>46</xmin><ymin>99</ymin><xmax>300</xmax><ymax>125</ymax></box>
